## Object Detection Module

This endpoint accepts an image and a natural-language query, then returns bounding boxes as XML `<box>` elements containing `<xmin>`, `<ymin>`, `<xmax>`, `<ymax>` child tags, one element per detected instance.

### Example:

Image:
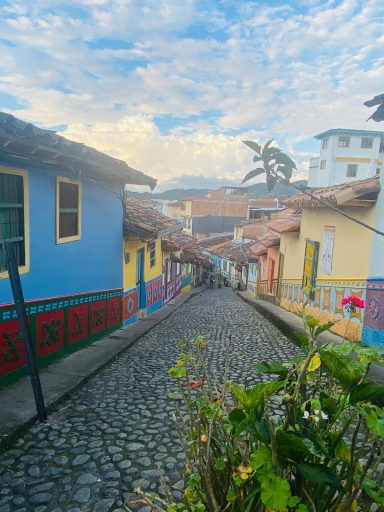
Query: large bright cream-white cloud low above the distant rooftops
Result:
<box><xmin>61</xmin><ymin>116</ymin><xmax>255</xmax><ymax>188</ymax></box>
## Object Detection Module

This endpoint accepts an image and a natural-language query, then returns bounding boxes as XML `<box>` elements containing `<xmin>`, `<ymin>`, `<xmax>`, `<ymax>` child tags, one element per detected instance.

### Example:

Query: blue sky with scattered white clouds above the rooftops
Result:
<box><xmin>0</xmin><ymin>0</ymin><xmax>384</xmax><ymax>191</ymax></box>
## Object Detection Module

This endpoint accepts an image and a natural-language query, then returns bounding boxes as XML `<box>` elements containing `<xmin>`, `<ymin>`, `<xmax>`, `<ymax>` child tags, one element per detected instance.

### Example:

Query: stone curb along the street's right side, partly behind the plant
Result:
<box><xmin>237</xmin><ymin>292</ymin><xmax>384</xmax><ymax>385</ymax></box>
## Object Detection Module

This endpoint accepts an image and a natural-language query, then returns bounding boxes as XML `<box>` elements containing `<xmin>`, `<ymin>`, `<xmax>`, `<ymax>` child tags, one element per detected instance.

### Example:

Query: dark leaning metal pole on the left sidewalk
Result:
<box><xmin>5</xmin><ymin>242</ymin><xmax>47</xmax><ymax>421</ymax></box>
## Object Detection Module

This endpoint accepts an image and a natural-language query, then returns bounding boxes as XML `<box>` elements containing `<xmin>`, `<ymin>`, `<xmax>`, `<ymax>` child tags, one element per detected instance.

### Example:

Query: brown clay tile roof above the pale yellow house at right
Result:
<box><xmin>286</xmin><ymin>176</ymin><xmax>380</xmax><ymax>208</ymax></box>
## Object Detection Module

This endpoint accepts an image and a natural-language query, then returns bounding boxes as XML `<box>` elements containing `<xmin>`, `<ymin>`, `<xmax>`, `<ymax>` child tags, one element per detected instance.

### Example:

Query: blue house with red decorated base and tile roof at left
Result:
<box><xmin>0</xmin><ymin>113</ymin><xmax>156</xmax><ymax>386</ymax></box>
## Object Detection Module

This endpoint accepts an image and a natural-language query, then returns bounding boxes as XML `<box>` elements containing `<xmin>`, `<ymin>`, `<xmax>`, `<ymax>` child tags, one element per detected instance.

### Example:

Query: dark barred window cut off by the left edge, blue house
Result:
<box><xmin>0</xmin><ymin>169</ymin><xmax>29</xmax><ymax>274</ymax></box>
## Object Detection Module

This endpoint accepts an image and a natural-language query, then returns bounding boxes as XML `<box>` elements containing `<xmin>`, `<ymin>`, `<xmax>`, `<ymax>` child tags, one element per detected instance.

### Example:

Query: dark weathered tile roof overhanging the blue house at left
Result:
<box><xmin>0</xmin><ymin>112</ymin><xmax>156</xmax><ymax>189</ymax></box>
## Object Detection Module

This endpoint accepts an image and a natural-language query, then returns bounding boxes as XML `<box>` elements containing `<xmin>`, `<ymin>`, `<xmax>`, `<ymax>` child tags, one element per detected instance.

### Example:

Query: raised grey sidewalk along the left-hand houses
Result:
<box><xmin>0</xmin><ymin>287</ymin><xmax>206</xmax><ymax>452</ymax></box>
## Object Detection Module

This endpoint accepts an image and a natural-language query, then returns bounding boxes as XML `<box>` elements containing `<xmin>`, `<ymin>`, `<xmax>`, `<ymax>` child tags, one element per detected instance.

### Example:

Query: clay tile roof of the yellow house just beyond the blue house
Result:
<box><xmin>124</xmin><ymin>197</ymin><xmax>182</xmax><ymax>239</ymax></box>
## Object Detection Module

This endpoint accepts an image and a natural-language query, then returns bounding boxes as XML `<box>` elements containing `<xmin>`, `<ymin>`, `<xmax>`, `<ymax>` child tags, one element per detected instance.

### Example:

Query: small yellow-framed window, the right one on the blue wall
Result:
<box><xmin>56</xmin><ymin>177</ymin><xmax>81</xmax><ymax>244</ymax></box>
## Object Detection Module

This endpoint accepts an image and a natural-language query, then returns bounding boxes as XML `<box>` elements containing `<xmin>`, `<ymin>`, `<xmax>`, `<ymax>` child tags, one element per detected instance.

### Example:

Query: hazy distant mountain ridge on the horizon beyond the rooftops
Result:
<box><xmin>127</xmin><ymin>180</ymin><xmax>308</xmax><ymax>201</ymax></box>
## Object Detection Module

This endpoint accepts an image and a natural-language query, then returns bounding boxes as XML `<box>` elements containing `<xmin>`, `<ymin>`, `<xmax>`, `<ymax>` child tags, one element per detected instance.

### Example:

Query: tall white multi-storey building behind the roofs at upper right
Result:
<box><xmin>308</xmin><ymin>128</ymin><xmax>384</xmax><ymax>187</ymax></box>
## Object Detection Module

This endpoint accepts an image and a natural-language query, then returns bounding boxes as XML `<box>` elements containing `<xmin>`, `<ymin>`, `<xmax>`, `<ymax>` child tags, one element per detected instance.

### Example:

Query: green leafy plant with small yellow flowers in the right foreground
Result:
<box><xmin>127</xmin><ymin>320</ymin><xmax>384</xmax><ymax>512</ymax></box>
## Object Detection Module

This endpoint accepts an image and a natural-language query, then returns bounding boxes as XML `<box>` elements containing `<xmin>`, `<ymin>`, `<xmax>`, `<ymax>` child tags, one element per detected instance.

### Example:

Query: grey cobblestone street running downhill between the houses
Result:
<box><xmin>0</xmin><ymin>288</ymin><xmax>304</xmax><ymax>512</ymax></box>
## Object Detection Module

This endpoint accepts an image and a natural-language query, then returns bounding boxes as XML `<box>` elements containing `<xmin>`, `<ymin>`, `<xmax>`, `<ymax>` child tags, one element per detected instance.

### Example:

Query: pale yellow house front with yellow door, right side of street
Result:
<box><xmin>279</xmin><ymin>203</ymin><xmax>375</xmax><ymax>341</ymax></box>
